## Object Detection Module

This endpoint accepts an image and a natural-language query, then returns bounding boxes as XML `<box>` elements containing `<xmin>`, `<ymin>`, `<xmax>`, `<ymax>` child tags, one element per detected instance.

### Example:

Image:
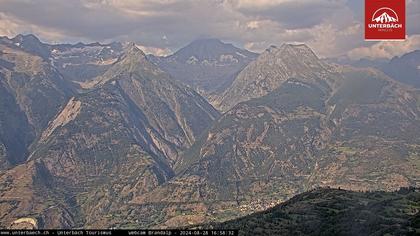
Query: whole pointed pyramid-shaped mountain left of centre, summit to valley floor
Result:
<box><xmin>0</xmin><ymin>42</ymin><xmax>219</xmax><ymax>228</ymax></box>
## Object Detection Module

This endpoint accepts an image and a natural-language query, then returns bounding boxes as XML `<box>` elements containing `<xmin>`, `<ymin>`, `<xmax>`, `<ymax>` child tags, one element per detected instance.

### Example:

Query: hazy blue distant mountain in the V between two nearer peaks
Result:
<box><xmin>151</xmin><ymin>39</ymin><xmax>257</xmax><ymax>101</ymax></box>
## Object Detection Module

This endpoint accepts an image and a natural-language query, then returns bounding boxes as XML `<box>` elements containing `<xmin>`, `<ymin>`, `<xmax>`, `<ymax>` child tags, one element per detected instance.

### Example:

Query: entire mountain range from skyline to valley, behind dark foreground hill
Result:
<box><xmin>0</xmin><ymin>35</ymin><xmax>420</xmax><ymax>232</ymax></box>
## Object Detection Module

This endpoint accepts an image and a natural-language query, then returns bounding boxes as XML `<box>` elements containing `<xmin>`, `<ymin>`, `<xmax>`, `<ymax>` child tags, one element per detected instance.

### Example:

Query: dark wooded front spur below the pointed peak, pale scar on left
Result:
<box><xmin>27</xmin><ymin>83</ymin><xmax>173</xmax><ymax>227</ymax></box>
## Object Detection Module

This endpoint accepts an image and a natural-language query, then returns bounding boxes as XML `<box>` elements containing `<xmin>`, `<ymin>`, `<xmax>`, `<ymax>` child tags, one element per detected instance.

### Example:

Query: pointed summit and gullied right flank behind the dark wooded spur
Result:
<box><xmin>83</xmin><ymin>44</ymin><xmax>219</xmax><ymax>166</ymax></box>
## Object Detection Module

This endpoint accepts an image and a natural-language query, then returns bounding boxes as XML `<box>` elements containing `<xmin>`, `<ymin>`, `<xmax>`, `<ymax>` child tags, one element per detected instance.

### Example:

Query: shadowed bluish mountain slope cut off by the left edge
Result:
<box><xmin>0</xmin><ymin>39</ymin><xmax>72</xmax><ymax>169</ymax></box>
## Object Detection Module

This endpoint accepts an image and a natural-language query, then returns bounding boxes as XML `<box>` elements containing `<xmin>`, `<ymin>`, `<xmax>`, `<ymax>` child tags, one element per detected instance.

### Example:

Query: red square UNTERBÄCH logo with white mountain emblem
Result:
<box><xmin>365</xmin><ymin>0</ymin><xmax>405</xmax><ymax>40</ymax></box>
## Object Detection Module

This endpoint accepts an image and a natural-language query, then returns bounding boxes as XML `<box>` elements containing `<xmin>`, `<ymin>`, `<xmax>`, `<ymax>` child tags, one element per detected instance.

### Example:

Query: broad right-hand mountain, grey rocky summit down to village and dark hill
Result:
<box><xmin>127</xmin><ymin>42</ymin><xmax>420</xmax><ymax>227</ymax></box>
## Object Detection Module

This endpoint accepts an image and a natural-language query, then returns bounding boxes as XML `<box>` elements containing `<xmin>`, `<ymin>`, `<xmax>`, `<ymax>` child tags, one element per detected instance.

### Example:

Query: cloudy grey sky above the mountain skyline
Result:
<box><xmin>0</xmin><ymin>0</ymin><xmax>420</xmax><ymax>59</ymax></box>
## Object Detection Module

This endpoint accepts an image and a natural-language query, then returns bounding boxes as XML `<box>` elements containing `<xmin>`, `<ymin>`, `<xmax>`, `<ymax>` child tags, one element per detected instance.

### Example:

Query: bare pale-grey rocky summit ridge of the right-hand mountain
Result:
<box><xmin>215</xmin><ymin>44</ymin><xmax>331</xmax><ymax>111</ymax></box>
